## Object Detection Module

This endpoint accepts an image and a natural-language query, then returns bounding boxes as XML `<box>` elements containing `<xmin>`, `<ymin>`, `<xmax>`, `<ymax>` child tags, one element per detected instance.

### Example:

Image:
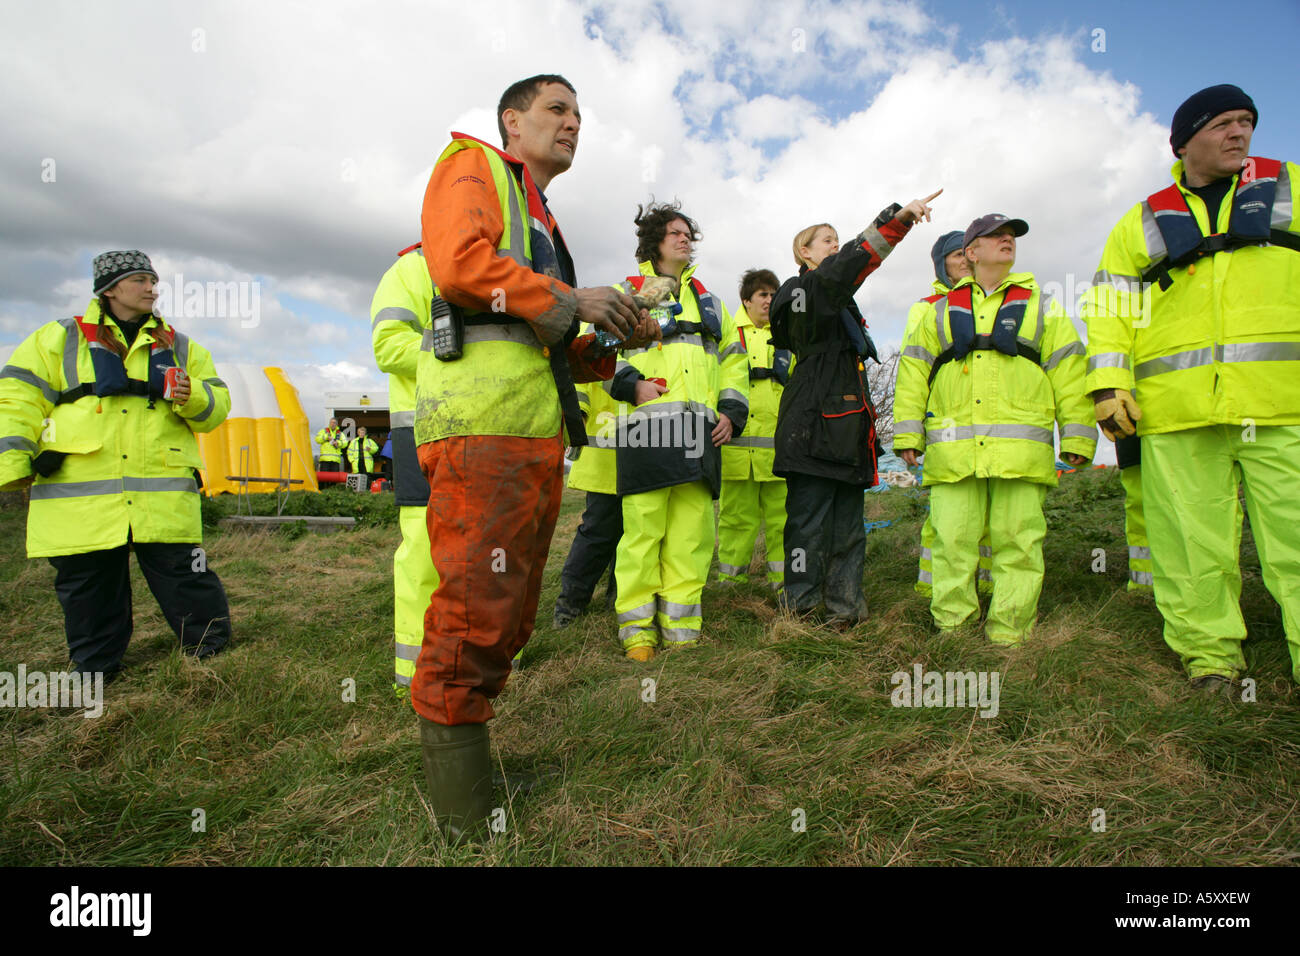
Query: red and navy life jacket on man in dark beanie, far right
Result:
<box><xmin>1141</xmin><ymin>156</ymin><xmax>1300</xmax><ymax>290</ymax></box>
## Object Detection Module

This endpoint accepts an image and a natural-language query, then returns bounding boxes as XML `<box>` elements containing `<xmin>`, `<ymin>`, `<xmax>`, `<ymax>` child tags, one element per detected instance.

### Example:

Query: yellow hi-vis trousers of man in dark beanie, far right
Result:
<box><xmin>1141</xmin><ymin>424</ymin><xmax>1300</xmax><ymax>682</ymax></box>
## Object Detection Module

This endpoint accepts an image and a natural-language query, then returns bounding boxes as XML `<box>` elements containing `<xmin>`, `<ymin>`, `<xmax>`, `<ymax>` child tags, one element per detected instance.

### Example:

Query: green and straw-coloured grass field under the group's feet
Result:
<box><xmin>0</xmin><ymin>468</ymin><xmax>1300</xmax><ymax>866</ymax></box>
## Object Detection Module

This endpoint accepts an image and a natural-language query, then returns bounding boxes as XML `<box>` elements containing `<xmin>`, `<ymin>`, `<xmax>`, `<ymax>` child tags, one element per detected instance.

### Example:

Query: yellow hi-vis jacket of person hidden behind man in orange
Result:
<box><xmin>371</xmin><ymin>248</ymin><xmax>433</xmax><ymax>428</ymax></box>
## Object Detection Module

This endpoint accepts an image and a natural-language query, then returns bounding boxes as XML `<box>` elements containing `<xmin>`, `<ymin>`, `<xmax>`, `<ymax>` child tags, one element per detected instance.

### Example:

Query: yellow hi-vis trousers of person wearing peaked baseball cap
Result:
<box><xmin>930</xmin><ymin>476</ymin><xmax>1047</xmax><ymax>644</ymax></box>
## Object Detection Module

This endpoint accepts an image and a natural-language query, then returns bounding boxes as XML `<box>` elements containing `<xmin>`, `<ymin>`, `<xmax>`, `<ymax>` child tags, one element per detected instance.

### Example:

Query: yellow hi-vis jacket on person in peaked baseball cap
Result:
<box><xmin>894</xmin><ymin>272</ymin><xmax>1097</xmax><ymax>485</ymax></box>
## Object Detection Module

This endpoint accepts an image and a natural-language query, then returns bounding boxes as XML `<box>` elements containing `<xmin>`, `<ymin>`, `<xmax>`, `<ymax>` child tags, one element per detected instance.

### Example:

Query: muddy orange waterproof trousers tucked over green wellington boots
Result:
<box><xmin>411</xmin><ymin>434</ymin><xmax>564</xmax><ymax>726</ymax></box>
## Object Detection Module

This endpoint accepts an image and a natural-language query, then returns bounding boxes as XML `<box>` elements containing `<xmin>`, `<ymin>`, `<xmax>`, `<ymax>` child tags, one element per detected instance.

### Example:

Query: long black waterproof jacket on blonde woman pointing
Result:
<box><xmin>772</xmin><ymin>206</ymin><xmax>909</xmax><ymax>488</ymax></box>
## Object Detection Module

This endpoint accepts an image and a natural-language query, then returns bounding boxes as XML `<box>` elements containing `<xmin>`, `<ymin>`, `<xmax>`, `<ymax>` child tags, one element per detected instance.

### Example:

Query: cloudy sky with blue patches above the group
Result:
<box><xmin>0</xmin><ymin>0</ymin><xmax>1300</xmax><ymax>463</ymax></box>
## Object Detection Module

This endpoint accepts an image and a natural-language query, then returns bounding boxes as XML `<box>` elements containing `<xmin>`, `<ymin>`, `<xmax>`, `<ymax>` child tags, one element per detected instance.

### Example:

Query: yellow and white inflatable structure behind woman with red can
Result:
<box><xmin>195</xmin><ymin>363</ymin><xmax>320</xmax><ymax>494</ymax></box>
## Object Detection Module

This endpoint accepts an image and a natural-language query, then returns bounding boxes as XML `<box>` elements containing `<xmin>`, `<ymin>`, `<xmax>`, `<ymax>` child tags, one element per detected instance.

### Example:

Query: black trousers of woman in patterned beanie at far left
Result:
<box><xmin>47</xmin><ymin>542</ymin><xmax>230</xmax><ymax>676</ymax></box>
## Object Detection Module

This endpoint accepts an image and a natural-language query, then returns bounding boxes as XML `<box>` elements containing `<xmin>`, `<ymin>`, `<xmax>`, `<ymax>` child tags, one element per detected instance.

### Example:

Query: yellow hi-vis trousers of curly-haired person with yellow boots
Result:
<box><xmin>614</xmin><ymin>481</ymin><xmax>714</xmax><ymax>649</ymax></box>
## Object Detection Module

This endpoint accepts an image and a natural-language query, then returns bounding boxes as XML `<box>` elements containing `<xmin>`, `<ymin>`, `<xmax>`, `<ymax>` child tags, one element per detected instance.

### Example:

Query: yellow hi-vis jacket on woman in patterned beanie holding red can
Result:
<box><xmin>0</xmin><ymin>300</ymin><xmax>230</xmax><ymax>558</ymax></box>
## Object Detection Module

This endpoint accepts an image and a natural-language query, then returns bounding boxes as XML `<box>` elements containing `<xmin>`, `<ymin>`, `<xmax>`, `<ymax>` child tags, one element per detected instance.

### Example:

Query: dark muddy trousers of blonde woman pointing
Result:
<box><xmin>783</xmin><ymin>473</ymin><xmax>867</xmax><ymax>623</ymax></box>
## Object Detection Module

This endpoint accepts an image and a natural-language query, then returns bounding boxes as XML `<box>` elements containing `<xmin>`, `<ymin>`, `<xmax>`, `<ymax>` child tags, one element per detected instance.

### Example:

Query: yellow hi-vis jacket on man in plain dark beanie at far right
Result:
<box><xmin>1082</xmin><ymin>160</ymin><xmax>1300</xmax><ymax>434</ymax></box>
